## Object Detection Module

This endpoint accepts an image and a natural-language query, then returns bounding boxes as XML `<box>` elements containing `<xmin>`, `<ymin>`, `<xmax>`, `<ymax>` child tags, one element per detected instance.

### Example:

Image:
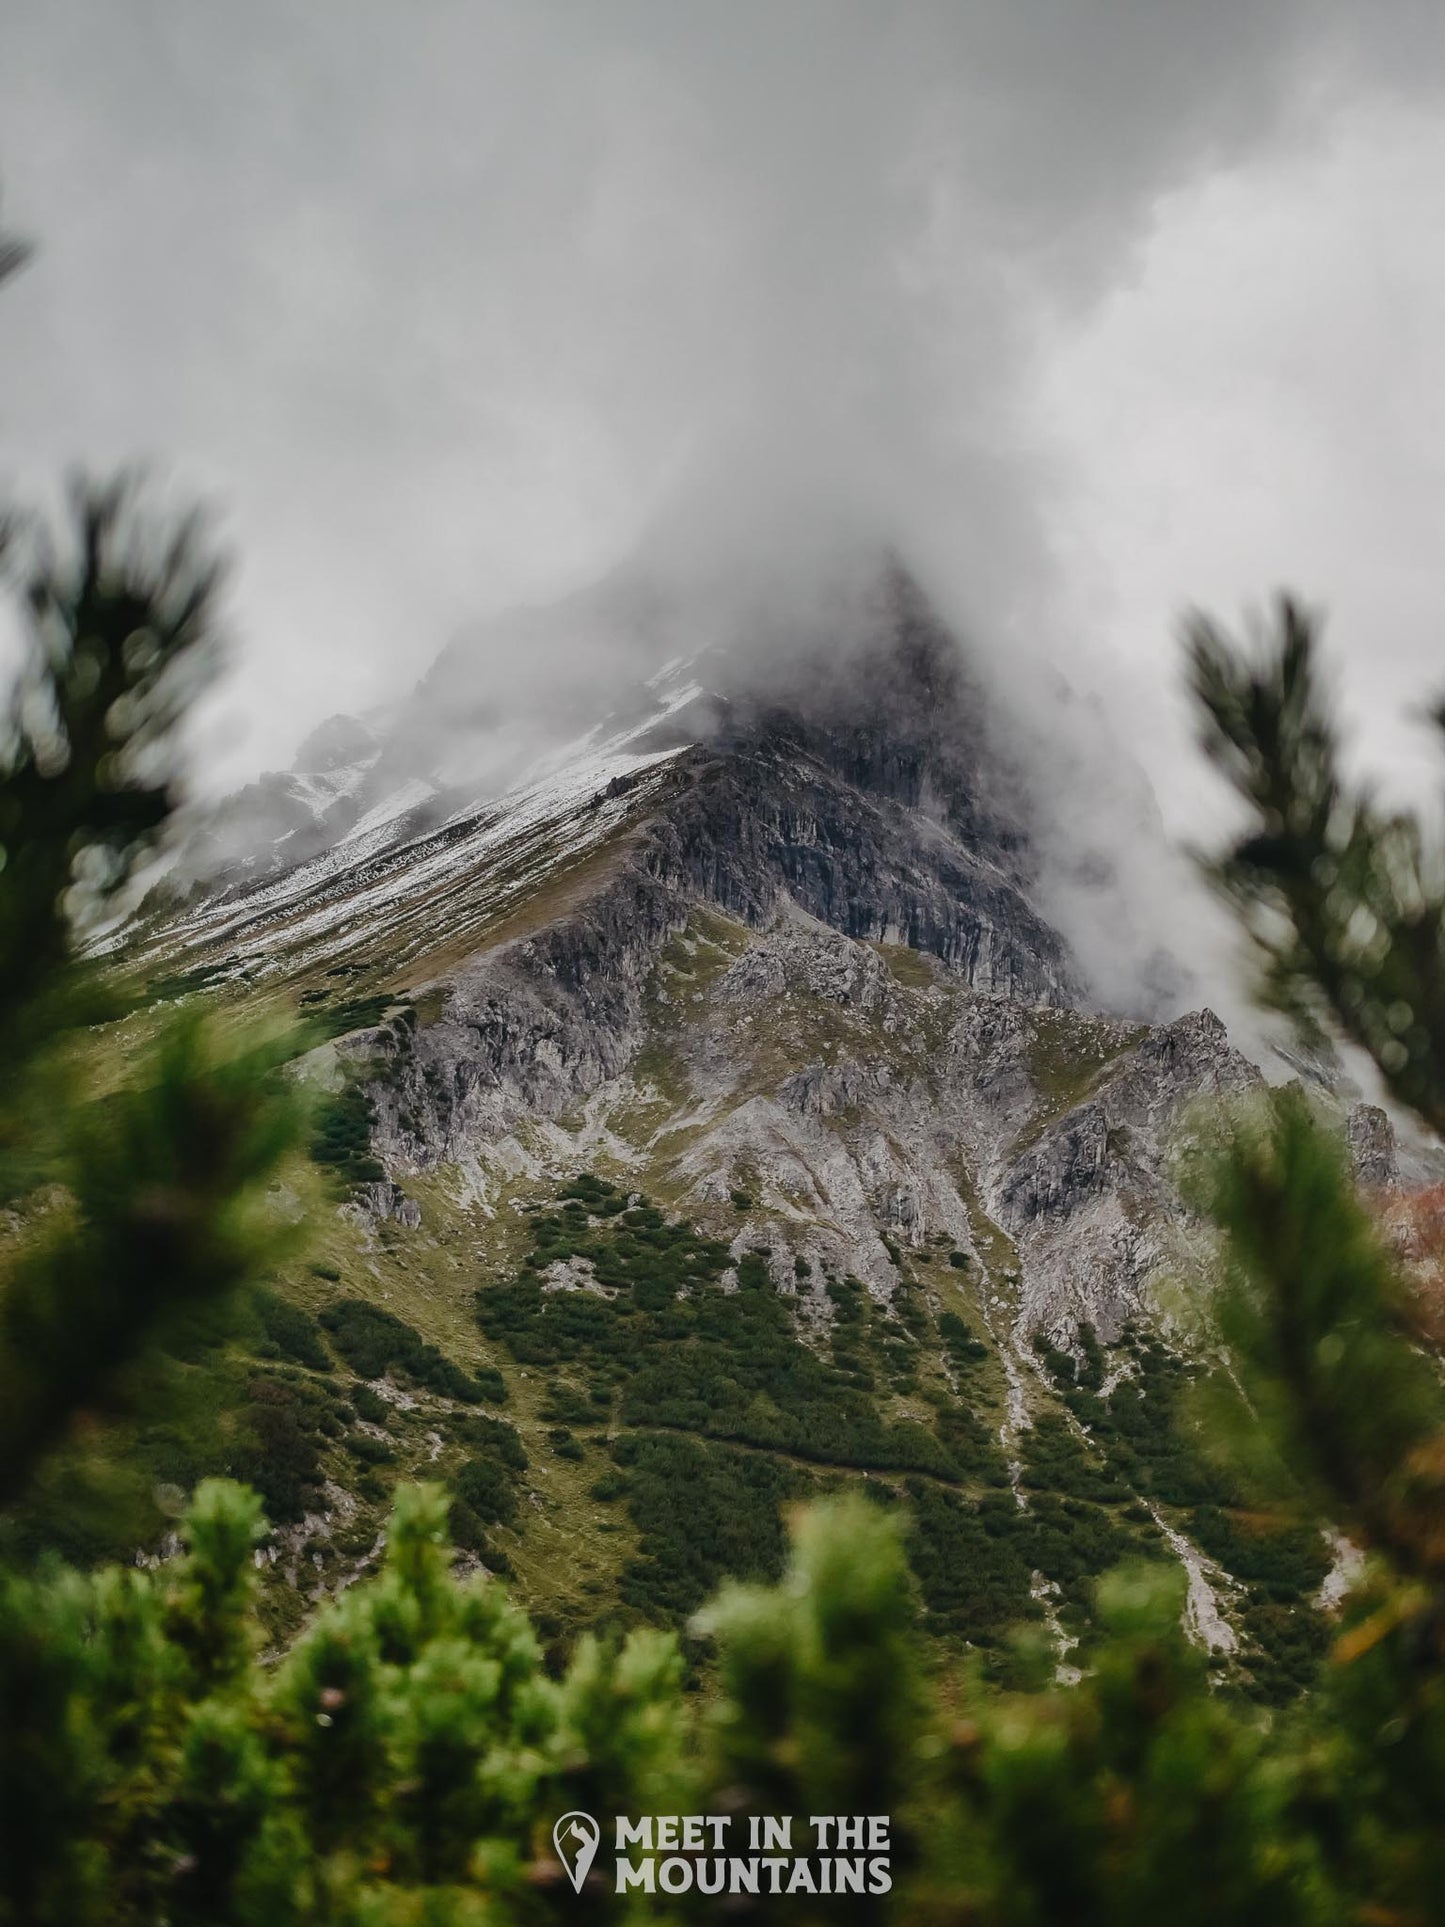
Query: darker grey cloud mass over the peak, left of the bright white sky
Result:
<box><xmin>0</xmin><ymin>0</ymin><xmax>1445</xmax><ymax>1017</ymax></box>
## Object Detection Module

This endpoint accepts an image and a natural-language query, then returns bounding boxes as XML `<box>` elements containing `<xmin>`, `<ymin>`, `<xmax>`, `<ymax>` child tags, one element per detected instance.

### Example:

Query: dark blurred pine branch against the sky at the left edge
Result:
<box><xmin>0</xmin><ymin>478</ymin><xmax>222</xmax><ymax>1109</ymax></box>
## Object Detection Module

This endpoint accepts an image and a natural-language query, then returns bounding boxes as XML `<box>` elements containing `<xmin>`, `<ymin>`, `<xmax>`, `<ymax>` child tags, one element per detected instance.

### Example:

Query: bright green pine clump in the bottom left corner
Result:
<box><xmin>0</xmin><ymin>1486</ymin><xmax>697</xmax><ymax>1927</ymax></box>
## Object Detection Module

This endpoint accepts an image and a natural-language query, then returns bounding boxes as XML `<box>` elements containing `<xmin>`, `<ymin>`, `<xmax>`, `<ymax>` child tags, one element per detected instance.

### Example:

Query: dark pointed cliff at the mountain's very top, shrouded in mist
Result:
<box><xmin>676</xmin><ymin>568</ymin><xmax>1071</xmax><ymax>1002</ymax></box>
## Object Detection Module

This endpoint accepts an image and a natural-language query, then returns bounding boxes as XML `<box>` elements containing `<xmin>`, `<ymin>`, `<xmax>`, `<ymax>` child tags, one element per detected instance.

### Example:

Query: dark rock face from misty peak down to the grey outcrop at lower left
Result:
<box><xmin>373</xmin><ymin>586</ymin><xmax>1077</xmax><ymax>1158</ymax></box>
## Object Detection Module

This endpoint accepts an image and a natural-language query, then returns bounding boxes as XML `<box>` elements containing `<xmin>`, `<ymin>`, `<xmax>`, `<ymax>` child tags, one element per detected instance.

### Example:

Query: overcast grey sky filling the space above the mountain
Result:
<box><xmin>0</xmin><ymin>0</ymin><xmax>1445</xmax><ymax>844</ymax></box>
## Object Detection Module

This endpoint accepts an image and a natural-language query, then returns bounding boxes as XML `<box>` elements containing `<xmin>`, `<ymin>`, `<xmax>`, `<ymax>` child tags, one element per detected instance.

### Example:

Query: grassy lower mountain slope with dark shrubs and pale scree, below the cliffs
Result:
<box><xmin>19</xmin><ymin>910</ymin><xmax>1329</xmax><ymax>1698</ymax></box>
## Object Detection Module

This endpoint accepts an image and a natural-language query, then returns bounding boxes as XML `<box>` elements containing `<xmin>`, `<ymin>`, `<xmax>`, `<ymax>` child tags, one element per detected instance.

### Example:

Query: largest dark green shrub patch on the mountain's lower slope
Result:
<box><xmin>487</xmin><ymin>1177</ymin><xmax>1225</xmax><ymax>1650</ymax></box>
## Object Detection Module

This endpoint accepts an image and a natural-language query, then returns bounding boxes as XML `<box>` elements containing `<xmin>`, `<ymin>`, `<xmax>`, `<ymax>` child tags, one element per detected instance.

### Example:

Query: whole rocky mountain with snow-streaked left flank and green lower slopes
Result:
<box><xmin>118</xmin><ymin>570</ymin><xmax>1399</xmax><ymax>1700</ymax></box>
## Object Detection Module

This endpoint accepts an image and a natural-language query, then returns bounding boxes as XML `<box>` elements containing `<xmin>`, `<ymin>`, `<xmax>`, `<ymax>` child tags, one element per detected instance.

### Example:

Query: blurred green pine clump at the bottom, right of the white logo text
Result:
<box><xmin>950</xmin><ymin>1567</ymin><xmax>1345</xmax><ymax>1927</ymax></box>
